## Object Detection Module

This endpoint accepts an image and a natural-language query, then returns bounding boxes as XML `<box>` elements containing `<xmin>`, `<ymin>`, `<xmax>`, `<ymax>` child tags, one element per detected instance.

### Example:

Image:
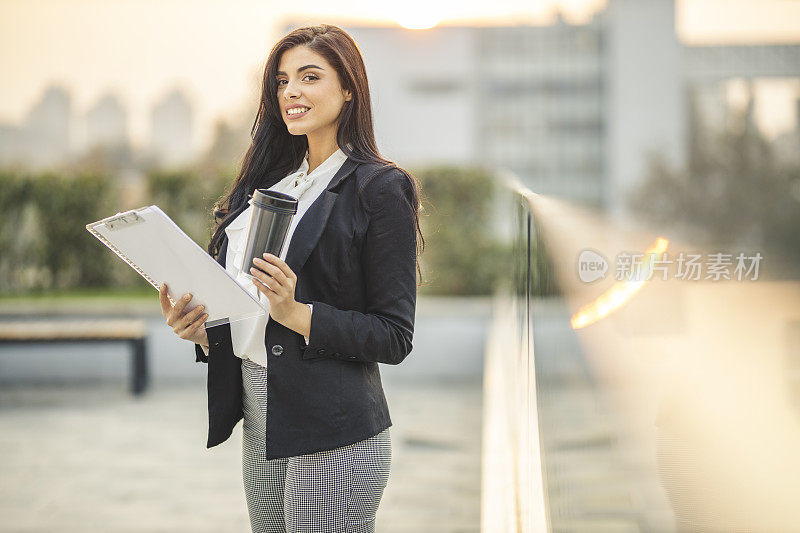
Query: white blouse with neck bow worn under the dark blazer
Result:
<box><xmin>202</xmin><ymin>148</ymin><xmax>347</xmax><ymax>367</ymax></box>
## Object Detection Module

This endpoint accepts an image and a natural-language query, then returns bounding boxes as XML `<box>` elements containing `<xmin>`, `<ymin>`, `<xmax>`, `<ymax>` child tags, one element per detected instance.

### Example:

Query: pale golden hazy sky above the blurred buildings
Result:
<box><xmin>0</xmin><ymin>0</ymin><xmax>800</xmax><ymax>150</ymax></box>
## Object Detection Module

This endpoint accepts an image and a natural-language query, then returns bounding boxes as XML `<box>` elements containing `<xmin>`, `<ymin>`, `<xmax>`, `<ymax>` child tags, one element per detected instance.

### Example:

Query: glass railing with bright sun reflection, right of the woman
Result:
<box><xmin>482</xmin><ymin>172</ymin><xmax>800</xmax><ymax>532</ymax></box>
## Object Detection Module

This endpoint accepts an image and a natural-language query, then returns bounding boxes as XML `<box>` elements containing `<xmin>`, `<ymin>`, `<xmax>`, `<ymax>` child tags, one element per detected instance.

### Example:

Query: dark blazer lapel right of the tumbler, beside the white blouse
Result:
<box><xmin>286</xmin><ymin>158</ymin><xmax>358</xmax><ymax>274</ymax></box>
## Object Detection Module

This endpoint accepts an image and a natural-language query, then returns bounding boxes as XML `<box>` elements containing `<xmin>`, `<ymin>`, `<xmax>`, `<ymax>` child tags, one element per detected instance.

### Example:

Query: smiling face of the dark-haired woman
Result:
<box><xmin>276</xmin><ymin>46</ymin><xmax>352</xmax><ymax>137</ymax></box>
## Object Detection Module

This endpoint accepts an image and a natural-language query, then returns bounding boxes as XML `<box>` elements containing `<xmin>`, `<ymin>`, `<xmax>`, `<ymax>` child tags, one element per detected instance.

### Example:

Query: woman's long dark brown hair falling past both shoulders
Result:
<box><xmin>208</xmin><ymin>24</ymin><xmax>425</xmax><ymax>278</ymax></box>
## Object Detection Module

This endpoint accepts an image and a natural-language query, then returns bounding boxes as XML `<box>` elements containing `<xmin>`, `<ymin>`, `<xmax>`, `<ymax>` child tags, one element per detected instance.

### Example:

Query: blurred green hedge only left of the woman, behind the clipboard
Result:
<box><xmin>0</xmin><ymin>169</ymin><xmax>233</xmax><ymax>296</ymax></box>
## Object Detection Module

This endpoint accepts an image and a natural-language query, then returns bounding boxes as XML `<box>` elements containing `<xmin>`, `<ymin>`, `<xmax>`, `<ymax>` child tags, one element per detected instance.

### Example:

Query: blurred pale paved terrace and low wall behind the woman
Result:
<box><xmin>0</xmin><ymin>293</ymin><xmax>489</xmax><ymax>533</ymax></box>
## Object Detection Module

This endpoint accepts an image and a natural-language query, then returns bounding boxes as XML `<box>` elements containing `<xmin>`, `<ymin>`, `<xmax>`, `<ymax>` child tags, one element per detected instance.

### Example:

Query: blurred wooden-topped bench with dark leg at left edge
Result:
<box><xmin>0</xmin><ymin>319</ymin><xmax>149</xmax><ymax>395</ymax></box>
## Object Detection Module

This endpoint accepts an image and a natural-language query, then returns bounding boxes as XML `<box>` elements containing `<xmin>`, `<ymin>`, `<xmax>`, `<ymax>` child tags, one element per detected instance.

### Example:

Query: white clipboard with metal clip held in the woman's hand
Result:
<box><xmin>86</xmin><ymin>205</ymin><xmax>269</xmax><ymax>328</ymax></box>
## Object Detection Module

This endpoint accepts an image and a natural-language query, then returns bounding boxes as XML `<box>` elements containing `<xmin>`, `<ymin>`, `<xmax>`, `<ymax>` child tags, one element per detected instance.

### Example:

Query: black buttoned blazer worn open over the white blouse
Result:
<box><xmin>195</xmin><ymin>158</ymin><xmax>417</xmax><ymax>459</ymax></box>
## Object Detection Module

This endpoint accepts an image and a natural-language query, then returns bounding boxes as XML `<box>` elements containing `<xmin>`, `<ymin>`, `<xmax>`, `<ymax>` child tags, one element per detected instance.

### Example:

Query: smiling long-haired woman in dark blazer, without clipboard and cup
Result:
<box><xmin>160</xmin><ymin>24</ymin><xmax>424</xmax><ymax>532</ymax></box>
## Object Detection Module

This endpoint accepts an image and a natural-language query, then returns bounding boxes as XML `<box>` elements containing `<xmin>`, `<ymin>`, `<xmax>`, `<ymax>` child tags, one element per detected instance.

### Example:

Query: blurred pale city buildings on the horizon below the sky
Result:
<box><xmin>0</xmin><ymin>0</ymin><xmax>800</xmax><ymax>222</ymax></box>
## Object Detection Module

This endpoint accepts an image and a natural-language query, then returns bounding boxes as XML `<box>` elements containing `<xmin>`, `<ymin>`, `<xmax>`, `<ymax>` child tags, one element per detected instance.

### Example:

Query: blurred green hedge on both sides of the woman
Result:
<box><xmin>0</xmin><ymin>166</ymin><xmax>510</xmax><ymax>295</ymax></box>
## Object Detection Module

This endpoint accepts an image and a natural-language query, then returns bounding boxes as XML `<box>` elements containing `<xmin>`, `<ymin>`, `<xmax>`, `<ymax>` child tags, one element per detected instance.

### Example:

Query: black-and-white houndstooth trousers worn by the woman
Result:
<box><xmin>242</xmin><ymin>359</ymin><xmax>392</xmax><ymax>533</ymax></box>
